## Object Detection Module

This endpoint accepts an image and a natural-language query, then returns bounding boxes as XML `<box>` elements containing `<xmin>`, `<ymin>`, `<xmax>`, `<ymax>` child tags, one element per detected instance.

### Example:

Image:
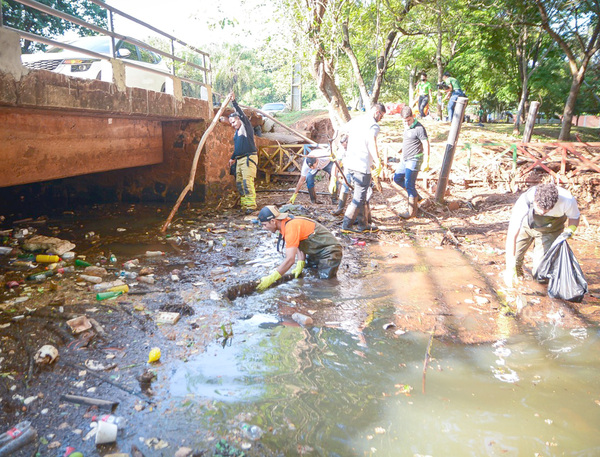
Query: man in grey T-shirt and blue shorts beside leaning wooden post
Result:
<box><xmin>394</xmin><ymin>105</ymin><xmax>430</xmax><ymax>219</ymax></box>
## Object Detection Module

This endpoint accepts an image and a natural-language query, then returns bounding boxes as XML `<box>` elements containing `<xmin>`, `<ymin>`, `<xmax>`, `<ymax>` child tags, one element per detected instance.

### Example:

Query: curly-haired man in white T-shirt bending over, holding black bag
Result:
<box><xmin>504</xmin><ymin>183</ymin><xmax>580</xmax><ymax>287</ymax></box>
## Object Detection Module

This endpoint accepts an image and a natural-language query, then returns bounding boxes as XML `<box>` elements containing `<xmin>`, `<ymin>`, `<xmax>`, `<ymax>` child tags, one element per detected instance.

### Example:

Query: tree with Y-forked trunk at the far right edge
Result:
<box><xmin>535</xmin><ymin>0</ymin><xmax>600</xmax><ymax>141</ymax></box>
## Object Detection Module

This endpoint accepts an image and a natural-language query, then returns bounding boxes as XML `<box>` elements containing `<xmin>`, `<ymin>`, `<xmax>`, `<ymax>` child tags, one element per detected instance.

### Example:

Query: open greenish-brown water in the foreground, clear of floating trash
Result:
<box><xmin>157</xmin><ymin>246</ymin><xmax>600</xmax><ymax>456</ymax></box>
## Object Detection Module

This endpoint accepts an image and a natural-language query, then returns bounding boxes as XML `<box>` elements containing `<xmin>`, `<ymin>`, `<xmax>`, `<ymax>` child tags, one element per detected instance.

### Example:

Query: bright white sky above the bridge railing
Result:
<box><xmin>106</xmin><ymin>0</ymin><xmax>274</xmax><ymax>48</ymax></box>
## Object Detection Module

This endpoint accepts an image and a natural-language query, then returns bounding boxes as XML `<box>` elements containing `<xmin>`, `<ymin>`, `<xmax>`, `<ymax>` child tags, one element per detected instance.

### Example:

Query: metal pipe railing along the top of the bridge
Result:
<box><xmin>0</xmin><ymin>0</ymin><xmax>212</xmax><ymax>94</ymax></box>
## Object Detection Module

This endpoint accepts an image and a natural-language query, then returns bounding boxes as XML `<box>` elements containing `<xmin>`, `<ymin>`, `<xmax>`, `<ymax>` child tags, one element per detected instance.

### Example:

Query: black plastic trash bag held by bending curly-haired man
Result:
<box><xmin>535</xmin><ymin>235</ymin><xmax>588</xmax><ymax>303</ymax></box>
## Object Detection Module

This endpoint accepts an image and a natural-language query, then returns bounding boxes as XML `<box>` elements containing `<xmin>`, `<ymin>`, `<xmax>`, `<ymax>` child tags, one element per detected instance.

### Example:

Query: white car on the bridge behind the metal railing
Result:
<box><xmin>21</xmin><ymin>35</ymin><xmax>170</xmax><ymax>92</ymax></box>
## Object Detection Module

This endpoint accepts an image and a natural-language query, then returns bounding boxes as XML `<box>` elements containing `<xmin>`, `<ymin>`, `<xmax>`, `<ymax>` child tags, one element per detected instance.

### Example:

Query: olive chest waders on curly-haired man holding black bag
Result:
<box><xmin>515</xmin><ymin>204</ymin><xmax>567</xmax><ymax>276</ymax></box>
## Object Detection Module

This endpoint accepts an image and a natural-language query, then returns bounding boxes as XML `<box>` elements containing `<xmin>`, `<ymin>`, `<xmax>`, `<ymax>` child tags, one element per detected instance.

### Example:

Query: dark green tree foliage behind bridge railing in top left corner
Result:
<box><xmin>0</xmin><ymin>0</ymin><xmax>107</xmax><ymax>54</ymax></box>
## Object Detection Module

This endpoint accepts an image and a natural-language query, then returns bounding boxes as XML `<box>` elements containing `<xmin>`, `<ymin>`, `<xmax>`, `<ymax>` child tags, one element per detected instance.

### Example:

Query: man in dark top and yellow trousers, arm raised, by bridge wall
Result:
<box><xmin>229</xmin><ymin>92</ymin><xmax>258</xmax><ymax>214</ymax></box>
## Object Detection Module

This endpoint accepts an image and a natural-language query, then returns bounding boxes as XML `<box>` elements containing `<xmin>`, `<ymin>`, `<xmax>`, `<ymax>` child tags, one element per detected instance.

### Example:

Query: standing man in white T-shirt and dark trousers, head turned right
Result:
<box><xmin>342</xmin><ymin>103</ymin><xmax>386</xmax><ymax>232</ymax></box>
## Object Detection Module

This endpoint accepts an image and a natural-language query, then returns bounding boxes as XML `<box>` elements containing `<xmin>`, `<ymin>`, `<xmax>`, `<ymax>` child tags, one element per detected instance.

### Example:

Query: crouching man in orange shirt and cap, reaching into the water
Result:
<box><xmin>256</xmin><ymin>206</ymin><xmax>342</xmax><ymax>290</ymax></box>
